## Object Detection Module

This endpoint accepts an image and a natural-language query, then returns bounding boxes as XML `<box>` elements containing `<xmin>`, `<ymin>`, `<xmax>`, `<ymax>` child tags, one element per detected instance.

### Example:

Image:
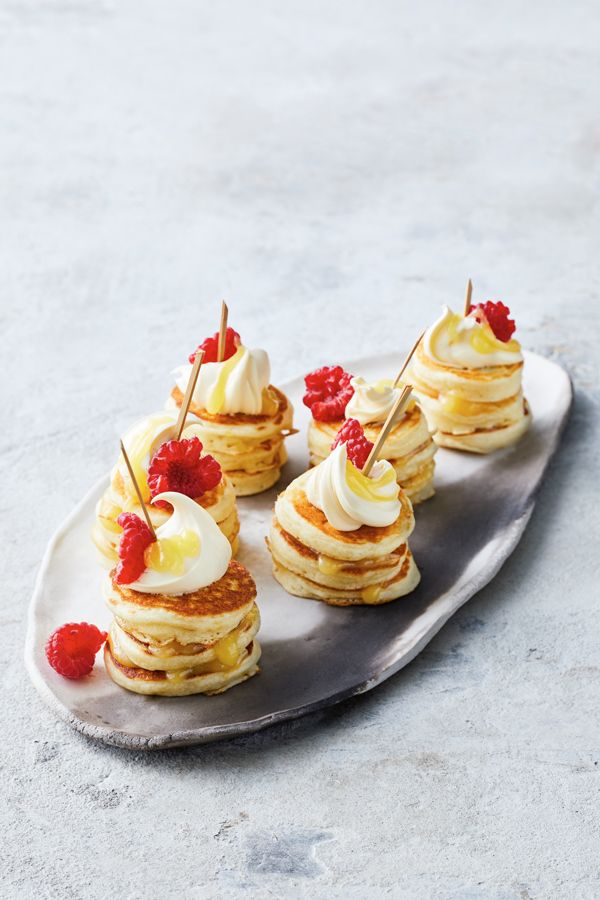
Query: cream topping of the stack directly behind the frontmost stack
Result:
<box><xmin>116</xmin><ymin>410</ymin><xmax>204</xmax><ymax>503</ymax></box>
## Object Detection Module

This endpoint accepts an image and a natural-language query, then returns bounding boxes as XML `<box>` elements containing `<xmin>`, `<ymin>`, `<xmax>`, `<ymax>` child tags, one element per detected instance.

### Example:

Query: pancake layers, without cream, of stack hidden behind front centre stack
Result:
<box><xmin>308</xmin><ymin>403</ymin><xmax>437</xmax><ymax>505</ymax></box>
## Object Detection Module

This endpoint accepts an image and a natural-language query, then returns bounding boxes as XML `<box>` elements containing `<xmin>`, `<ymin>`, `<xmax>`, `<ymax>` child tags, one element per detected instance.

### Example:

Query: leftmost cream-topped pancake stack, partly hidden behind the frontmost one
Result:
<box><xmin>92</xmin><ymin>411</ymin><xmax>240</xmax><ymax>568</ymax></box>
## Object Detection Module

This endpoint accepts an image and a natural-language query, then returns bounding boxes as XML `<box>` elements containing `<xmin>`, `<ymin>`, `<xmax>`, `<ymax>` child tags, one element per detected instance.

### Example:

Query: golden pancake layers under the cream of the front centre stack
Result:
<box><xmin>267</xmin><ymin>472</ymin><xmax>421</xmax><ymax>606</ymax></box>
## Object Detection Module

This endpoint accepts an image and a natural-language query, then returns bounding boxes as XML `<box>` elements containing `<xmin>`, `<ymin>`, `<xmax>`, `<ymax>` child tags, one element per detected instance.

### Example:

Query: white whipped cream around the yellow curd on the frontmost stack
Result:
<box><xmin>127</xmin><ymin>491</ymin><xmax>231</xmax><ymax>596</ymax></box>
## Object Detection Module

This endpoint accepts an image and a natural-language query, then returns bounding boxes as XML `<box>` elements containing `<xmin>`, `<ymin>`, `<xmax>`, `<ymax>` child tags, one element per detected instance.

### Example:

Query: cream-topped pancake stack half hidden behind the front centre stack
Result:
<box><xmin>304</xmin><ymin>370</ymin><xmax>437</xmax><ymax>505</ymax></box>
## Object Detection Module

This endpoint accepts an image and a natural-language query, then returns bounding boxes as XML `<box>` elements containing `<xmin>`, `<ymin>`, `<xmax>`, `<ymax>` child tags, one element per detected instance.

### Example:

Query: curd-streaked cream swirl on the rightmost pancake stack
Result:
<box><xmin>423</xmin><ymin>306</ymin><xmax>523</xmax><ymax>369</ymax></box>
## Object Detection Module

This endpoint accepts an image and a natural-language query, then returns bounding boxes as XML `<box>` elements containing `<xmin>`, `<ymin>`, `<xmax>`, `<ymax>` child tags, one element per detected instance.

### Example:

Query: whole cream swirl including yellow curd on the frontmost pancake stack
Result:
<box><xmin>127</xmin><ymin>491</ymin><xmax>231</xmax><ymax>596</ymax></box>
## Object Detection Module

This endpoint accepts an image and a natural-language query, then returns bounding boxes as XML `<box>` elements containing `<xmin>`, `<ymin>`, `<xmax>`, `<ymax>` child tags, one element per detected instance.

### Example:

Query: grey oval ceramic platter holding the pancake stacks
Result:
<box><xmin>25</xmin><ymin>353</ymin><xmax>572</xmax><ymax>750</ymax></box>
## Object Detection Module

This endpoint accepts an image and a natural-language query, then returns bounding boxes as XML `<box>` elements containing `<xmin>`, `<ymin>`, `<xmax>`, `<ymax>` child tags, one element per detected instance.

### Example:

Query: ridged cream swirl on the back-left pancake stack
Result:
<box><xmin>173</xmin><ymin>346</ymin><xmax>271</xmax><ymax>416</ymax></box>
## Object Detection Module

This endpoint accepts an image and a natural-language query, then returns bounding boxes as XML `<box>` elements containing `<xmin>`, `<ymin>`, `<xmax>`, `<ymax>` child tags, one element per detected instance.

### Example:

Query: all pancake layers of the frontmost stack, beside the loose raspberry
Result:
<box><xmin>104</xmin><ymin>560</ymin><xmax>261</xmax><ymax>697</ymax></box>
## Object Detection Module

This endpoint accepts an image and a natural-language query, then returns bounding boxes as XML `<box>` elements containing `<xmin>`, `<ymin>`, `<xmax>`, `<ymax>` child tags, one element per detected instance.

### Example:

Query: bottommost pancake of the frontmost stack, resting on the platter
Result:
<box><xmin>104</xmin><ymin>635</ymin><xmax>261</xmax><ymax>697</ymax></box>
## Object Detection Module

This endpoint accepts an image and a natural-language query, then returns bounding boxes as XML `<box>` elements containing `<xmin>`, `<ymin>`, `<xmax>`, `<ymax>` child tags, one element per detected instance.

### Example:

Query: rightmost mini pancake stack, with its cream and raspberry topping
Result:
<box><xmin>408</xmin><ymin>303</ymin><xmax>531</xmax><ymax>453</ymax></box>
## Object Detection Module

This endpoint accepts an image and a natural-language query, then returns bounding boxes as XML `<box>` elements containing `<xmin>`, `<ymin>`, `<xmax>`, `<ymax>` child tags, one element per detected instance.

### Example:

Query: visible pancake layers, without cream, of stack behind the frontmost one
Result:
<box><xmin>92</xmin><ymin>468</ymin><xmax>240</xmax><ymax>569</ymax></box>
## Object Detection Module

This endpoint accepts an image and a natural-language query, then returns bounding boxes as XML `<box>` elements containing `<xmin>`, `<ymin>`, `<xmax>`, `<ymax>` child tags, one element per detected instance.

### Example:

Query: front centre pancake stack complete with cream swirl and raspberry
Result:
<box><xmin>267</xmin><ymin>419</ymin><xmax>420</xmax><ymax>606</ymax></box>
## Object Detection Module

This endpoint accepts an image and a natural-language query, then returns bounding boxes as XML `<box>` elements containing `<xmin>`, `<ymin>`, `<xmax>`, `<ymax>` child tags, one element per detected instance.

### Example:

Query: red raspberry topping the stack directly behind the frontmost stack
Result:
<box><xmin>148</xmin><ymin>437</ymin><xmax>222</xmax><ymax>508</ymax></box>
